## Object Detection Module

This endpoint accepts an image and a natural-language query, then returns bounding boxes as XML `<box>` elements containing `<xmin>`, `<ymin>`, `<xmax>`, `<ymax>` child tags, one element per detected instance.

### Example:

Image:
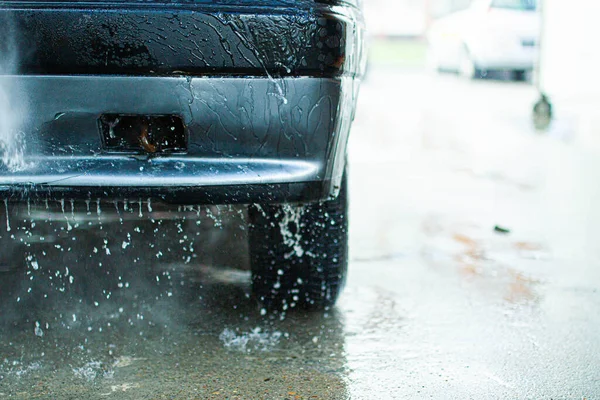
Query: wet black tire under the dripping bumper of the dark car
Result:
<box><xmin>249</xmin><ymin>176</ymin><xmax>348</xmax><ymax>310</ymax></box>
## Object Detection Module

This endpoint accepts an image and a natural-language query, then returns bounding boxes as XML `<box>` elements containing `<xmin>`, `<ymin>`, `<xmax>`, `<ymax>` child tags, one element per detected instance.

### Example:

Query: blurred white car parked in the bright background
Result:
<box><xmin>428</xmin><ymin>0</ymin><xmax>540</xmax><ymax>80</ymax></box>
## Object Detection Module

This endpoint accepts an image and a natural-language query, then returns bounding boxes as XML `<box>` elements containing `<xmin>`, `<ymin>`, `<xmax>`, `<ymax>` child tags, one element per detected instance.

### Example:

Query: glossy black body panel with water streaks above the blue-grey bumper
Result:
<box><xmin>0</xmin><ymin>0</ymin><xmax>359</xmax><ymax>76</ymax></box>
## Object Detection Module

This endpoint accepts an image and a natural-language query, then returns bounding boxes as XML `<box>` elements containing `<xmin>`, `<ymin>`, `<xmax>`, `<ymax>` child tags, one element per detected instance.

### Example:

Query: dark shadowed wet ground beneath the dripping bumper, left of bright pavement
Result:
<box><xmin>0</xmin><ymin>203</ymin><xmax>345</xmax><ymax>399</ymax></box>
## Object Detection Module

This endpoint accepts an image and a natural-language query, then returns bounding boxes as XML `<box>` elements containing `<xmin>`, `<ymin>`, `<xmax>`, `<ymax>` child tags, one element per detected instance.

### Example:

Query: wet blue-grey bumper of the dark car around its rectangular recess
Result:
<box><xmin>0</xmin><ymin>76</ymin><xmax>353</xmax><ymax>203</ymax></box>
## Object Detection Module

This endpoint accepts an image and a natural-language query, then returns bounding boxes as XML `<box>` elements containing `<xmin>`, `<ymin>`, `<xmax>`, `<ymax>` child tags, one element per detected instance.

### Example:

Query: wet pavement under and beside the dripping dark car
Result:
<box><xmin>0</xmin><ymin>68</ymin><xmax>600</xmax><ymax>399</ymax></box>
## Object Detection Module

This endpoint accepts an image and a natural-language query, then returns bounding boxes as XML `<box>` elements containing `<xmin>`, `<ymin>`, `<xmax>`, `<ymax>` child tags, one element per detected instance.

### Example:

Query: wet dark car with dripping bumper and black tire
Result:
<box><xmin>0</xmin><ymin>0</ymin><xmax>364</xmax><ymax>309</ymax></box>
